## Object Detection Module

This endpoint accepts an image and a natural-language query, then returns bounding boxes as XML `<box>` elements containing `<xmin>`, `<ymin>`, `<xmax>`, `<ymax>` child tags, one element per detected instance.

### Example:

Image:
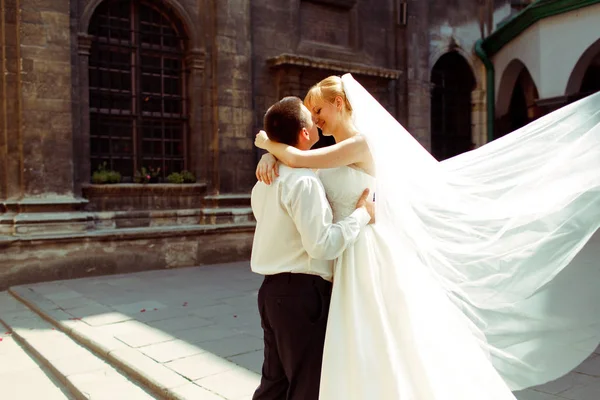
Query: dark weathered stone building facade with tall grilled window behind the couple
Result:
<box><xmin>0</xmin><ymin>0</ymin><xmax>536</xmax><ymax>289</ymax></box>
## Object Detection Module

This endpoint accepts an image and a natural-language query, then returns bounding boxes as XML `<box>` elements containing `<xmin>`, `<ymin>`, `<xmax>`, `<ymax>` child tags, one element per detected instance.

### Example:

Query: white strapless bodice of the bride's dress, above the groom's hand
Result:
<box><xmin>317</xmin><ymin>167</ymin><xmax>375</xmax><ymax>222</ymax></box>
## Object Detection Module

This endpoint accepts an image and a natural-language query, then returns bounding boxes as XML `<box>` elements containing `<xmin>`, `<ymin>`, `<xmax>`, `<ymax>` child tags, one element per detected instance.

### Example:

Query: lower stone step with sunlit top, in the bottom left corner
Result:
<box><xmin>0</xmin><ymin>292</ymin><xmax>156</xmax><ymax>399</ymax></box>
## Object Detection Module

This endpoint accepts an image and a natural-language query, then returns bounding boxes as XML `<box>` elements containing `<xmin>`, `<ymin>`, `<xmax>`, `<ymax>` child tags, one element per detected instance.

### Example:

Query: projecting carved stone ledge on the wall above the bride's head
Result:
<box><xmin>267</xmin><ymin>53</ymin><xmax>402</xmax><ymax>80</ymax></box>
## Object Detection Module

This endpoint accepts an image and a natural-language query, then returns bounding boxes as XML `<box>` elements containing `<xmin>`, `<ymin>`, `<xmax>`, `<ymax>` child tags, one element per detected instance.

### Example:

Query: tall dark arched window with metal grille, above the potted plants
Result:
<box><xmin>89</xmin><ymin>0</ymin><xmax>188</xmax><ymax>182</ymax></box>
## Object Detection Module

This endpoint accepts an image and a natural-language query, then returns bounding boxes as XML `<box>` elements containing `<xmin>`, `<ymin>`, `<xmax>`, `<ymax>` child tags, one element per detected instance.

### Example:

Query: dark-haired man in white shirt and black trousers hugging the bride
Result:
<box><xmin>251</xmin><ymin>97</ymin><xmax>374</xmax><ymax>400</ymax></box>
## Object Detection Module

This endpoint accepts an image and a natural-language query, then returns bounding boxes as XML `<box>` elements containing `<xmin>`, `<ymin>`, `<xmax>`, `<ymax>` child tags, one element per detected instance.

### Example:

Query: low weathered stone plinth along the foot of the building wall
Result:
<box><xmin>0</xmin><ymin>228</ymin><xmax>253</xmax><ymax>290</ymax></box>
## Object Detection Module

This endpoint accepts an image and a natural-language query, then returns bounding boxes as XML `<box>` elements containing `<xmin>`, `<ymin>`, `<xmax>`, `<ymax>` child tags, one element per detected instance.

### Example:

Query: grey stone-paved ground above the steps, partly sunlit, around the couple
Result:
<box><xmin>1</xmin><ymin>263</ymin><xmax>600</xmax><ymax>400</ymax></box>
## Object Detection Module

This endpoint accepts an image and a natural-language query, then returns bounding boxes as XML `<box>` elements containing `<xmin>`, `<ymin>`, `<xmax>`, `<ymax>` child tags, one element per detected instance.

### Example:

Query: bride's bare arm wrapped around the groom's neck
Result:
<box><xmin>255</xmin><ymin>131</ymin><xmax>370</xmax><ymax>168</ymax></box>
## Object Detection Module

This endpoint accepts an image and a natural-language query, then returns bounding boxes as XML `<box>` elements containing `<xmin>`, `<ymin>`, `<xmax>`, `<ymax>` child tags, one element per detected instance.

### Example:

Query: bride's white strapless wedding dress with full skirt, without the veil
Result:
<box><xmin>318</xmin><ymin>167</ymin><xmax>514</xmax><ymax>400</ymax></box>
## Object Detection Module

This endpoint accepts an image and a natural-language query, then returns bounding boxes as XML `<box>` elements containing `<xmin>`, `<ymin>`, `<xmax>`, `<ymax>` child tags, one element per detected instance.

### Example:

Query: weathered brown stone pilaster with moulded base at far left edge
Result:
<box><xmin>0</xmin><ymin>0</ymin><xmax>90</xmax><ymax>235</ymax></box>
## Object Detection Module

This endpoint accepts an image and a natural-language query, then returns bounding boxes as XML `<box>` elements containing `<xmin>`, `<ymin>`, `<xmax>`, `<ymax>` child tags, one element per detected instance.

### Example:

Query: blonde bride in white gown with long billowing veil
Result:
<box><xmin>256</xmin><ymin>74</ymin><xmax>600</xmax><ymax>400</ymax></box>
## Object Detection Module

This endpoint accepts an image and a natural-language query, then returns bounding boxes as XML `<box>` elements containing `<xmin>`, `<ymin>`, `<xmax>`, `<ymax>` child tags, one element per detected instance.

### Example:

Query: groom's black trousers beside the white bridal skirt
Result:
<box><xmin>253</xmin><ymin>273</ymin><xmax>331</xmax><ymax>400</ymax></box>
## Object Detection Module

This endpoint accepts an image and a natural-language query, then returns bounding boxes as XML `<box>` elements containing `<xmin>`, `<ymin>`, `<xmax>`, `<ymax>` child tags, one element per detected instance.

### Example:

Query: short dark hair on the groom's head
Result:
<box><xmin>263</xmin><ymin>96</ymin><xmax>309</xmax><ymax>146</ymax></box>
